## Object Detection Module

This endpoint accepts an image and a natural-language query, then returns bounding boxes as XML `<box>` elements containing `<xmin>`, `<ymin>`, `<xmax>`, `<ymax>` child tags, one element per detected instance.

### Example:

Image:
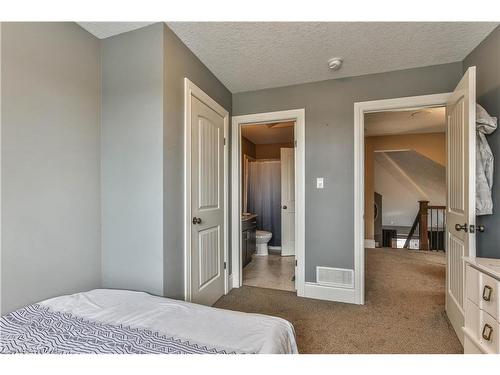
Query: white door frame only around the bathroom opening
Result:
<box><xmin>231</xmin><ymin>108</ymin><xmax>306</xmax><ymax>296</ymax></box>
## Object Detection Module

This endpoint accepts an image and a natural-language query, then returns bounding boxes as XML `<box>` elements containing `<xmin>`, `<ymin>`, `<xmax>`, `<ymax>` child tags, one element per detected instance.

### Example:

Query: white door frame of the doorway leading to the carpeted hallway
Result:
<box><xmin>354</xmin><ymin>93</ymin><xmax>451</xmax><ymax>305</ymax></box>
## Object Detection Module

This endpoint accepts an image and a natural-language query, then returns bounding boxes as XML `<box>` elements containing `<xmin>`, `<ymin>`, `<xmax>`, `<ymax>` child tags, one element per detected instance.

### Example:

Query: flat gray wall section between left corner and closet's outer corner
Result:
<box><xmin>101</xmin><ymin>24</ymin><xmax>163</xmax><ymax>295</ymax></box>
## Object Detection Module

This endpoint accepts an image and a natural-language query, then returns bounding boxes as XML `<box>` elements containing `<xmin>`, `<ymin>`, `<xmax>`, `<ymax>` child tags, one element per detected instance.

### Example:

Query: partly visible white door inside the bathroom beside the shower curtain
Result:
<box><xmin>281</xmin><ymin>148</ymin><xmax>295</xmax><ymax>256</ymax></box>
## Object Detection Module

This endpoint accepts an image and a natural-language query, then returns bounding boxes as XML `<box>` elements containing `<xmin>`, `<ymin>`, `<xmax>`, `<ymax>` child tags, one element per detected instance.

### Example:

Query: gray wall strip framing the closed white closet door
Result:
<box><xmin>163</xmin><ymin>25</ymin><xmax>232</xmax><ymax>298</ymax></box>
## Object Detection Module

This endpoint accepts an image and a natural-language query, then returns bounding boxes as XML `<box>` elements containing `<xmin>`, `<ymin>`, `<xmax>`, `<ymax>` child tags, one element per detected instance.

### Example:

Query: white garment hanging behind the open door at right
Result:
<box><xmin>476</xmin><ymin>104</ymin><xmax>497</xmax><ymax>215</ymax></box>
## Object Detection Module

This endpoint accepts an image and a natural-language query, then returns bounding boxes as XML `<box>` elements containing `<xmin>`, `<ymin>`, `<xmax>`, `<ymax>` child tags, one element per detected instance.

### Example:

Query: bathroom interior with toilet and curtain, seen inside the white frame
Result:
<box><xmin>241</xmin><ymin>121</ymin><xmax>296</xmax><ymax>291</ymax></box>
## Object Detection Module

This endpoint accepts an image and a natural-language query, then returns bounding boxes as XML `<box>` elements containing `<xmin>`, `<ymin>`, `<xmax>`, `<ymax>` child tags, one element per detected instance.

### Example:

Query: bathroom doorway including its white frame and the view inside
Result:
<box><xmin>231</xmin><ymin>110</ymin><xmax>305</xmax><ymax>296</ymax></box>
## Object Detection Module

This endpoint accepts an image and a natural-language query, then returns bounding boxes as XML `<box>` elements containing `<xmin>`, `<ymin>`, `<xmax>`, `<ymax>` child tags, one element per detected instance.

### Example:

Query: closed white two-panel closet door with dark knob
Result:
<box><xmin>191</xmin><ymin>97</ymin><xmax>225</xmax><ymax>305</ymax></box>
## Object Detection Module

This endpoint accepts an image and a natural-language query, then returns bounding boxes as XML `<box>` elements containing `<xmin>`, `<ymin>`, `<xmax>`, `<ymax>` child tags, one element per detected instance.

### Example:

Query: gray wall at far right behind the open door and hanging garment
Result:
<box><xmin>463</xmin><ymin>27</ymin><xmax>500</xmax><ymax>258</ymax></box>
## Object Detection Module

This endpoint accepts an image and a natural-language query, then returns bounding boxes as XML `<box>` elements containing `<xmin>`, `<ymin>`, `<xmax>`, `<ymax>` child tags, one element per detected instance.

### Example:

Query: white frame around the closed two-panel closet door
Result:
<box><xmin>184</xmin><ymin>78</ymin><xmax>229</xmax><ymax>301</ymax></box>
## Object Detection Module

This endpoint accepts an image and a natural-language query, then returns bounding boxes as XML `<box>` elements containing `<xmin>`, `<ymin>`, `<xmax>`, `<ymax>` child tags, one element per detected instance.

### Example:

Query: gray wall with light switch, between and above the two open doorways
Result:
<box><xmin>233</xmin><ymin>62</ymin><xmax>462</xmax><ymax>282</ymax></box>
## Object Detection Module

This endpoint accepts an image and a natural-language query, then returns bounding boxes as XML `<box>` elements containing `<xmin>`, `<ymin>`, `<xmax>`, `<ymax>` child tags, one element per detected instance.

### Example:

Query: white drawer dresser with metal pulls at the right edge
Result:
<box><xmin>464</xmin><ymin>258</ymin><xmax>500</xmax><ymax>354</ymax></box>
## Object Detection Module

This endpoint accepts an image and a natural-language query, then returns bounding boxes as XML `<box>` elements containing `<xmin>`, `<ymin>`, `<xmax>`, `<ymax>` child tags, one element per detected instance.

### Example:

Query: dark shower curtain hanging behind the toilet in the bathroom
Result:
<box><xmin>248</xmin><ymin>160</ymin><xmax>281</xmax><ymax>246</ymax></box>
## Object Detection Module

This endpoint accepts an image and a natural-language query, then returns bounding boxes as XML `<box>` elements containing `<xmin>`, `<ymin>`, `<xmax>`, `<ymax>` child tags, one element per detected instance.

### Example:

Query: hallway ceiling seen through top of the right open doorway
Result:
<box><xmin>365</xmin><ymin>107</ymin><xmax>445</xmax><ymax>137</ymax></box>
